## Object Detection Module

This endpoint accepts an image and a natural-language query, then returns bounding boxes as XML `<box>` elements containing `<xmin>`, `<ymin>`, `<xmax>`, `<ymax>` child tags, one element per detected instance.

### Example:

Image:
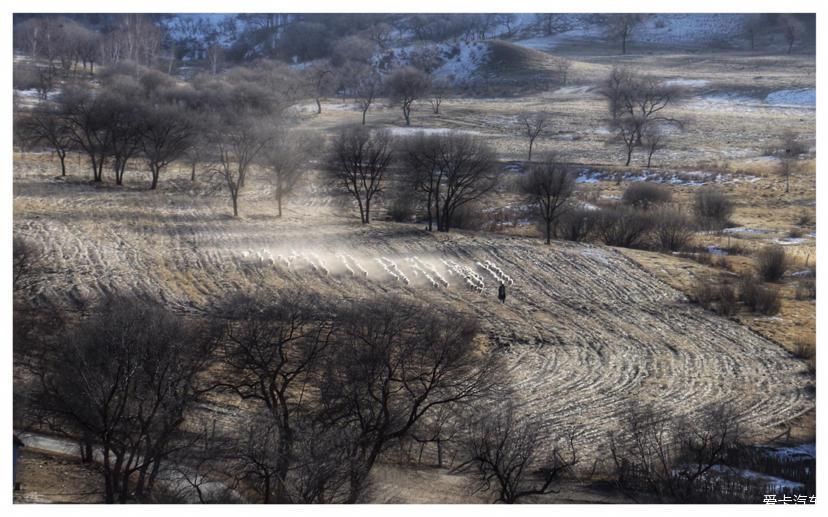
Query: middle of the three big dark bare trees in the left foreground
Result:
<box><xmin>215</xmin><ymin>293</ymin><xmax>333</xmax><ymax>503</ymax></box>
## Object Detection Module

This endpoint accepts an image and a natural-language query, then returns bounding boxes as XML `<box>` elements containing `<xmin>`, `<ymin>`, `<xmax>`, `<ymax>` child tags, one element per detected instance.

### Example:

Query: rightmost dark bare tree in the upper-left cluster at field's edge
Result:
<box><xmin>140</xmin><ymin>106</ymin><xmax>193</xmax><ymax>190</ymax></box>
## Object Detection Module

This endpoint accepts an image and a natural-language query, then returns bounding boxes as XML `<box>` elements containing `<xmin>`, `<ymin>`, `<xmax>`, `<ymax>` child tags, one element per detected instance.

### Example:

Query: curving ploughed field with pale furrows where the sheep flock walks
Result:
<box><xmin>14</xmin><ymin>163</ymin><xmax>814</xmax><ymax>456</ymax></box>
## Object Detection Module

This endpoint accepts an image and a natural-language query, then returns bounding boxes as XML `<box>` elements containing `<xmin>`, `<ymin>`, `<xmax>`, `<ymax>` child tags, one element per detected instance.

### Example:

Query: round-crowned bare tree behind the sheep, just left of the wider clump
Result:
<box><xmin>328</xmin><ymin>126</ymin><xmax>393</xmax><ymax>224</ymax></box>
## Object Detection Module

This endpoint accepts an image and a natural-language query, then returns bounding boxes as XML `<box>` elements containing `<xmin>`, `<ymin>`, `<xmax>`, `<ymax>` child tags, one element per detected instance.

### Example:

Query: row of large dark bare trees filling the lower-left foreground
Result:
<box><xmin>15</xmin><ymin>282</ymin><xmax>584</xmax><ymax>503</ymax></box>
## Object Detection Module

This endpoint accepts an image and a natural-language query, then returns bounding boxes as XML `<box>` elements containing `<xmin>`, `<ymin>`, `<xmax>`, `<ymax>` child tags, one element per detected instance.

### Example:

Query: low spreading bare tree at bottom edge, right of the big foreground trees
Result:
<box><xmin>465</xmin><ymin>405</ymin><xmax>578</xmax><ymax>504</ymax></box>
